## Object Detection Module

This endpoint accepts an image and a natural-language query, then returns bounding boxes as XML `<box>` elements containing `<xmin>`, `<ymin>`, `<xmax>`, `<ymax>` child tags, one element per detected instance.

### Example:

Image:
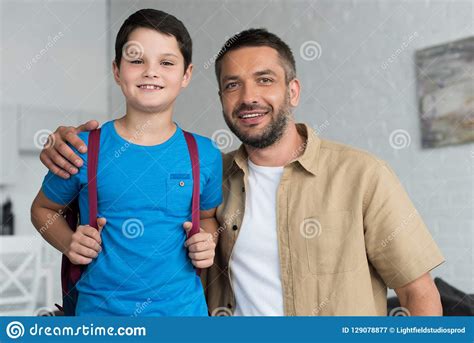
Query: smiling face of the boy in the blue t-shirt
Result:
<box><xmin>113</xmin><ymin>28</ymin><xmax>192</xmax><ymax>113</ymax></box>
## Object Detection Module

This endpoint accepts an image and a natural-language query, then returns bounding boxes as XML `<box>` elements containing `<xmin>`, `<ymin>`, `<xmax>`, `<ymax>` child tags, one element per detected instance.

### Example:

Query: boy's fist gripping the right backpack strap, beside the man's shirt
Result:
<box><xmin>183</xmin><ymin>222</ymin><xmax>216</xmax><ymax>268</ymax></box>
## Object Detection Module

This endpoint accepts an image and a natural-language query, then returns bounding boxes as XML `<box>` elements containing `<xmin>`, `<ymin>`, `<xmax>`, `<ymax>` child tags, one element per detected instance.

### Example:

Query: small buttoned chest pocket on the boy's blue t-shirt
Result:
<box><xmin>166</xmin><ymin>172</ymin><xmax>193</xmax><ymax>211</ymax></box>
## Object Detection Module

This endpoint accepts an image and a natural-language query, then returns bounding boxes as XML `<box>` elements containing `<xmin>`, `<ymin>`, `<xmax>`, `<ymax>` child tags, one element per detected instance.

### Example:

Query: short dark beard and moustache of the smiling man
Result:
<box><xmin>224</xmin><ymin>96</ymin><xmax>291</xmax><ymax>149</ymax></box>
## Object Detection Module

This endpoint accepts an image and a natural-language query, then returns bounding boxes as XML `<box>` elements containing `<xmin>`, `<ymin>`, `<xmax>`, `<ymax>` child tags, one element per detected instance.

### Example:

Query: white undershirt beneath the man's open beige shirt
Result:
<box><xmin>230</xmin><ymin>160</ymin><xmax>284</xmax><ymax>316</ymax></box>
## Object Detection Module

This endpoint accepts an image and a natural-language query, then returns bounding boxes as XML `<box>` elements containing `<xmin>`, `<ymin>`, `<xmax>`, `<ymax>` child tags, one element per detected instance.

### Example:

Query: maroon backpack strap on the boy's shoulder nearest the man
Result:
<box><xmin>183</xmin><ymin>130</ymin><xmax>201</xmax><ymax>275</ymax></box>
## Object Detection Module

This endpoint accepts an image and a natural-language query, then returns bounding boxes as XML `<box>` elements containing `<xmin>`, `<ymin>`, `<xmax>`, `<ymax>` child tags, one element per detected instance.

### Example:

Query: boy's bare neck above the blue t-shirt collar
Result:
<box><xmin>115</xmin><ymin>108</ymin><xmax>176</xmax><ymax>145</ymax></box>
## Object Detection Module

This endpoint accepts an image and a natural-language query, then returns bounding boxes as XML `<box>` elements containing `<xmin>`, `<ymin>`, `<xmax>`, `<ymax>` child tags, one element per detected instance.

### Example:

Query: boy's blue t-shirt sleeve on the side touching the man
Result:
<box><xmin>201</xmin><ymin>147</ymin><xmax>222</xmax><ymax>211</ymax></box>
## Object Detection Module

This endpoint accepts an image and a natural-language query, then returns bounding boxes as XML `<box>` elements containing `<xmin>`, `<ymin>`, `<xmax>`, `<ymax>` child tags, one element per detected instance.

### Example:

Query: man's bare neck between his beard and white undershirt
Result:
<box><xmin>245</xmin><ymin>120</ymin><xmax>305</xmax><ymax>167</ymax></box>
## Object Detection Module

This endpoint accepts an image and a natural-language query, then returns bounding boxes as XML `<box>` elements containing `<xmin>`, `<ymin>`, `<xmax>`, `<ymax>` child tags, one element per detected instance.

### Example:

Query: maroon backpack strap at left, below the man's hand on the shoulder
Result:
<box><xmin>87</xmin><ymin>129</ymin><xmax>100</xmax><ymax>229</ymax></box>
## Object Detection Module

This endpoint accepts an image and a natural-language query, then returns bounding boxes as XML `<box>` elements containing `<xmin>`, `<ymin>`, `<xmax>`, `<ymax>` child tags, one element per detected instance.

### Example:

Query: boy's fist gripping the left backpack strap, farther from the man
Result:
<box><xmin>64</xmin><ymin>218</ymin><xmax>106</xmax><ymax>264</ymax></box>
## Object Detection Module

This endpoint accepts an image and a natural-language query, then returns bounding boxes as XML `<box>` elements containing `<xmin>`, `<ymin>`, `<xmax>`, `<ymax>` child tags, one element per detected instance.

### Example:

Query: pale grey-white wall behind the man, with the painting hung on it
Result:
<box><xmin>110</xmin><ymin>0</ymin><xmax>474</xmax><ymax>293</ymax></box>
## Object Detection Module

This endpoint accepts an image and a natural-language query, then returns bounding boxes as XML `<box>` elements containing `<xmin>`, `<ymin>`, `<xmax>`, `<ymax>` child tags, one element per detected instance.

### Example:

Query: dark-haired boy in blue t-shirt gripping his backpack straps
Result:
<box><xmin>31</xmin><ymin>9</ymin><xmax>222</xmax><ymax>316</ymax></box>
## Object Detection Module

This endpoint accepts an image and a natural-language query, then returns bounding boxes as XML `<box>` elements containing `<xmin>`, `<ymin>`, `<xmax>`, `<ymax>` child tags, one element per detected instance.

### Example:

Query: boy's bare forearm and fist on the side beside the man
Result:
<box><xmin>183</xmin><ymin>208</ymin><xmax>219</xmax><ymax>268</ymax></box>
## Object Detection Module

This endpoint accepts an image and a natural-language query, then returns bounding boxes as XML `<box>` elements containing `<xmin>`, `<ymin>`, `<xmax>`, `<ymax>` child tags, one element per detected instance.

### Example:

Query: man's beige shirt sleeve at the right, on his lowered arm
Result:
<box><xmin>363</xmin><ymin>161</ymin><xmax>444</xmax><ymax>288</ymax></box>
